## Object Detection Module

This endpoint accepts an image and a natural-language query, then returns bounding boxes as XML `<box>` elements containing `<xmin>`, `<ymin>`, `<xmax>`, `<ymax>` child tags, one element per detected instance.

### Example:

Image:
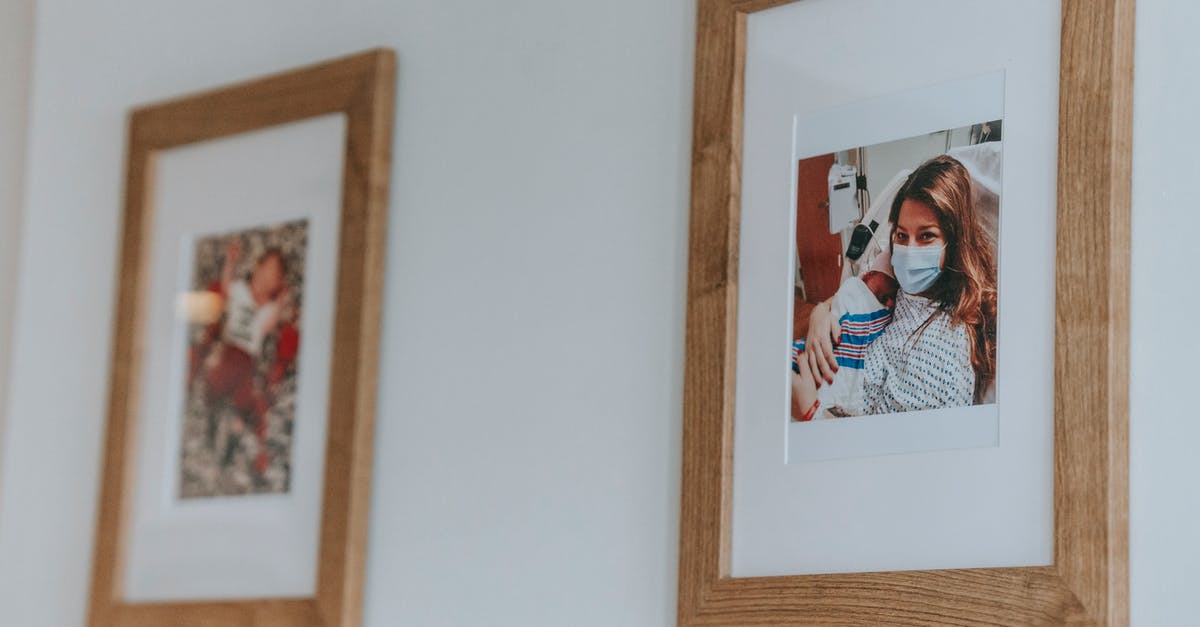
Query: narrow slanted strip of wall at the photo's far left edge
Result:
<box><xmin>0</xmin><ymin>0</ymin><xmax>34</xmax><ymax>468</ymax></box>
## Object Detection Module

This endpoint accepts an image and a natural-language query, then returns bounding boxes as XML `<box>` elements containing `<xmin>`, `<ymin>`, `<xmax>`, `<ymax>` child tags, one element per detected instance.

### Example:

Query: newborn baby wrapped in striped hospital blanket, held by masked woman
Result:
<box><xmin>792</xmin><ymin>270</ymin><xmax>900</xmax><ymax>420</ymax></box>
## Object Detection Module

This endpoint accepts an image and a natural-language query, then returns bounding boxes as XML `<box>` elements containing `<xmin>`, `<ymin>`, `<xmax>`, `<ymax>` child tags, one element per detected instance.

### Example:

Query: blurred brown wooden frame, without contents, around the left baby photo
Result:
<box><xmin>89</xmin><ymin>49</ymin><xmax>396</xmax><ymax>627</ymax></box>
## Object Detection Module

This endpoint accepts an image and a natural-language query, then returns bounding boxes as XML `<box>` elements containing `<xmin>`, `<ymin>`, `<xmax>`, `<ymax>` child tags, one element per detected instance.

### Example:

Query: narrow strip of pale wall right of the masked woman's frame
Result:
<box><xmin>1129</xmin><ymin>0</ymin><xmax>1200</xmax><ymax>626</ymax></box>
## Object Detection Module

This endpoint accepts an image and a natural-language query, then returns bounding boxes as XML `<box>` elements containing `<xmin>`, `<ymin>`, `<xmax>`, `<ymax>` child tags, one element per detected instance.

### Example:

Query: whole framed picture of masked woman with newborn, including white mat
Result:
<box><xmin>679</xmin><ymin>0</ymin><xmax>1134</xmax><ymax>625</ymax></box>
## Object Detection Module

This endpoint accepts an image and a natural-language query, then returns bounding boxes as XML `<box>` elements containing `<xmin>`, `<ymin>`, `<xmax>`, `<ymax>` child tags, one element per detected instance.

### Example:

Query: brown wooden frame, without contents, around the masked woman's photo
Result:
<box><xmin>678</xmin><ymin>0</ymin><xmax>1134</xmax><ymax>626</ymax></box>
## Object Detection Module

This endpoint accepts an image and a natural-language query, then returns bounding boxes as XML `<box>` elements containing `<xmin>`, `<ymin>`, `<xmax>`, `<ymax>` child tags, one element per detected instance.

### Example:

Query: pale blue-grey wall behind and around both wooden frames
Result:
<box><xmin>0</xmin><ymin>0</ymin><xmax>1200</xmax><ymax>627</ymax></box>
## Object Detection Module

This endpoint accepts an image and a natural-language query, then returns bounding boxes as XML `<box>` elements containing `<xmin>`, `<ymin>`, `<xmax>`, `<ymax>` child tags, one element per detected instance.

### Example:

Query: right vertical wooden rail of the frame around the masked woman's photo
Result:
<box><xmin>1055</xmin><ymin>0</ymin><xmax>1134</xmax><ymax>623</ymax></box>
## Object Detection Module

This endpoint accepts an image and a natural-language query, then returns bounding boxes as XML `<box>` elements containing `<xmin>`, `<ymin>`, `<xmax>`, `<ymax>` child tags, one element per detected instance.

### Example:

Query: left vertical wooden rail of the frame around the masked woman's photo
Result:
<box><xmin>678</xmin><ymin>0</ymin><xmax>745</xmax><ymax>625</ymax></box>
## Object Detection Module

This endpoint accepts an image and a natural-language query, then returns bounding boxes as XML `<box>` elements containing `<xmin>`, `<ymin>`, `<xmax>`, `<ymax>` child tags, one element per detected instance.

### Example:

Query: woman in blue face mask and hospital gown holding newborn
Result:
<box><xmin>792</xmin><ymin>155</ymin><xmax>996</xmax><ymax>419</ymax></box>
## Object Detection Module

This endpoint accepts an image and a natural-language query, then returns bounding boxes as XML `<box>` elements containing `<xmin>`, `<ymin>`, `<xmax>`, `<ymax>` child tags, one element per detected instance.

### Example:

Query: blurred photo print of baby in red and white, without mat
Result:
<box><xmin>179</xmin><ymin>220</ymin><xmax>308</xmax><ymax>500</ymax></box>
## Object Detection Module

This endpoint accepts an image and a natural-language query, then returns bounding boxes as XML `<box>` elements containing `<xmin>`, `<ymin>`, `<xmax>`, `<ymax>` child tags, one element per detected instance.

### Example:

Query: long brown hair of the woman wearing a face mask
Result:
<box><xmin>889</xmin><ymin>155</ymin><xmax>996</xmax><ymax>401</ymax></box>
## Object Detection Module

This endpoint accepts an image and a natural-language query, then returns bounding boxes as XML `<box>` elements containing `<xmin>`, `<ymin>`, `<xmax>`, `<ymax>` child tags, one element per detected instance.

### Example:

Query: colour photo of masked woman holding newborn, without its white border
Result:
<box><xmin>790</xmin><ymin>120</ymin><xmax>1003</xmax><ymax>423</ymax></box>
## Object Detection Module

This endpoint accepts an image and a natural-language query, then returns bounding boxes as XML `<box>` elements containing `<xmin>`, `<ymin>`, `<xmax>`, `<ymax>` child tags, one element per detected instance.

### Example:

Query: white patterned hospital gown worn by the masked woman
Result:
<box><xmin>830</xmin><ymin>291</ymin><xmax>974</xmax><ymax>416</ymax></box>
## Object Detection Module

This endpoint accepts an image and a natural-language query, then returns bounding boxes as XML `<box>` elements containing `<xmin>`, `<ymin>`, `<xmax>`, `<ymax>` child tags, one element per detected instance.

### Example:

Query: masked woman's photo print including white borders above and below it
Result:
<box><xmin>782</xmin><ymin>72</ymin><xmax>1004</xmax><ymax>462</ymax></box>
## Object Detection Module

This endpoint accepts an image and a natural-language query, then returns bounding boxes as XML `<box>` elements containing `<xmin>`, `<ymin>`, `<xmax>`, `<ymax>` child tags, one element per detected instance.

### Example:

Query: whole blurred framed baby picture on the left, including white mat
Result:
<box><xmin>89</xmin><ymin>49</ymin><xmax>396</xmax><ymax>627</ymax></box>
